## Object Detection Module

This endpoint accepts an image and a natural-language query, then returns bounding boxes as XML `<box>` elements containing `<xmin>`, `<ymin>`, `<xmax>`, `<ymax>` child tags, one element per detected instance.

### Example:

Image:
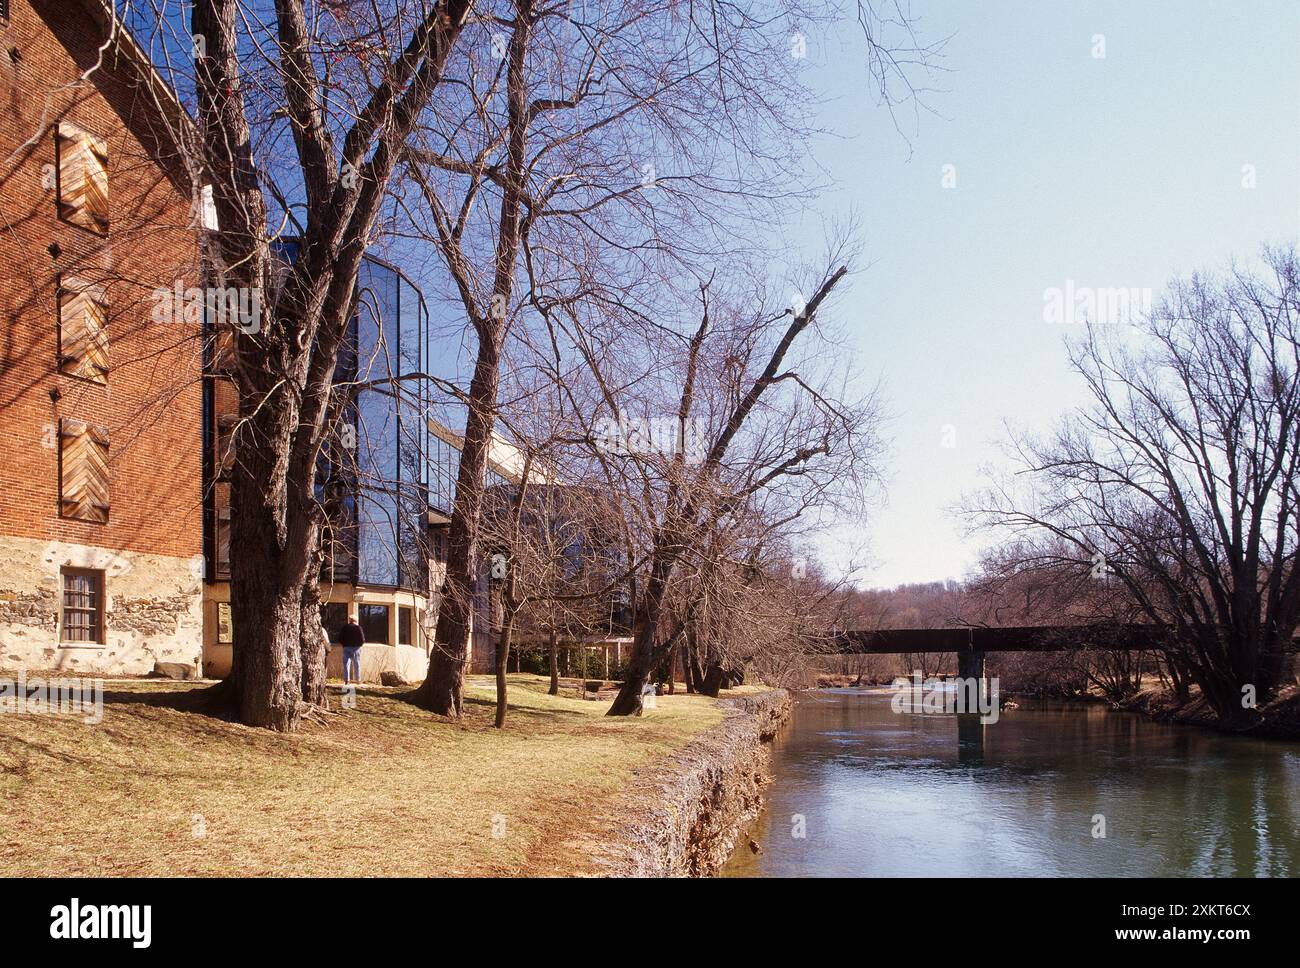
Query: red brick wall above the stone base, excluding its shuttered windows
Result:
<box><xmin>0</xmin><ymin>0</ymin><xmax>202</xmax><ymax>556</ymax></box>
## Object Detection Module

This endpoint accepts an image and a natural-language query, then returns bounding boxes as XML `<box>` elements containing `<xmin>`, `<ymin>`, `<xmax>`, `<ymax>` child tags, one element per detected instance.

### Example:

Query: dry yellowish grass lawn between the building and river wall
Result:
<box><xmin>0</xmin><ymin>674</ymin><xmax>722</xmax><ymax>876</ymax></box>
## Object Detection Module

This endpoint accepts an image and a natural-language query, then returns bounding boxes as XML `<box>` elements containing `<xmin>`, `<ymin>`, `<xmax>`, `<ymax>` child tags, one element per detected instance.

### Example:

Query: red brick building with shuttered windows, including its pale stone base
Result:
<box><xmin>0</xmin><ymin>0</ymin><xmax>203</xmax><ymax>673</ymax></box>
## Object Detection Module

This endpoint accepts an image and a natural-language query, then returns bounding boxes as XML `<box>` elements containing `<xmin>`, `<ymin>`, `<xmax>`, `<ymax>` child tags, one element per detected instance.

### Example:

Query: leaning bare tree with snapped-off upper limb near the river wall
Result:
<box><xmin>579</xmin><ymin>261</ymin><xmax>870</xmax><ymax>716</ymax></box>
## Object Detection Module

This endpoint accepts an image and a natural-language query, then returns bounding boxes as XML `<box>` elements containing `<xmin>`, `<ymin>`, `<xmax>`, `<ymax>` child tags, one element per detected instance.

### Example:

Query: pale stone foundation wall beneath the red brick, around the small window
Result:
<box><xmin>0</xmin><ymin>537</ymin><xmax>203</xmax><ymax>676</ymax></box>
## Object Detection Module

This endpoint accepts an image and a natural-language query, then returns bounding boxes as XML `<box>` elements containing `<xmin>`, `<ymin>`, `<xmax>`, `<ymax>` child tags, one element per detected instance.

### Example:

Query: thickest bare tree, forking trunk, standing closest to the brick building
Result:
<box><xmin>155</xmin><ymin>0</ymin><xmax>472</xmax><ymax>730</ymax></box>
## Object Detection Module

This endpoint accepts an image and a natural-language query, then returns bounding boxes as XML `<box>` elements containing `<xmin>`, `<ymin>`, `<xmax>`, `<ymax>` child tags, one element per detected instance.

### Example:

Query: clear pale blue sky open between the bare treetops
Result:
<box><xmin>792</xmin><ymin>0</ymin><xmax>1300</xmax><ymax>585</ymax></box>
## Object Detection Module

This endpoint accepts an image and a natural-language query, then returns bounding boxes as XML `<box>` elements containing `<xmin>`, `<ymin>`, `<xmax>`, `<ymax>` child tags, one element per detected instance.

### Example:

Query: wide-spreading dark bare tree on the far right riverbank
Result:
<box><xmin>972</xmin><ymin>249</ymin><xmax>1300</xmax><ymax>726</ymax></box>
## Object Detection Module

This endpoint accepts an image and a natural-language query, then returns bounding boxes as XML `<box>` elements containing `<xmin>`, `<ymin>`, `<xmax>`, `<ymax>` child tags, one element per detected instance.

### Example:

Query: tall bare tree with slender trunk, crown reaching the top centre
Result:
<box><xmin>406</xmin><ymin>0</ymin><xmax>935</xmax><ymax>716</ymax></box>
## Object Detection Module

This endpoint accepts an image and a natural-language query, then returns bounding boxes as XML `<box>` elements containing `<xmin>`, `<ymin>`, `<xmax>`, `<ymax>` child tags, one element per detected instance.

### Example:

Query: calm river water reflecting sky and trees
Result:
<box><xmin>722</xmin><ymin>689</ymin><xmax>1300</xmax><ymax>877</ymax></box>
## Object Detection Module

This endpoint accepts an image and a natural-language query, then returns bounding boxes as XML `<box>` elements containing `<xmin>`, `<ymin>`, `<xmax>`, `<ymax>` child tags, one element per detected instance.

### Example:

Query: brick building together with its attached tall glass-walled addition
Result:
<box><xmin>0</xmin><ymin>0</ymin><xmax>624</xmax><ymax>680</ymax></box>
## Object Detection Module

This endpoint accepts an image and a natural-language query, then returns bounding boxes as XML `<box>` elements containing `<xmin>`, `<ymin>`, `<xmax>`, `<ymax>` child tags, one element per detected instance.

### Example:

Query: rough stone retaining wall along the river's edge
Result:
<box><xmin>594</xmin><ymin>689</ymin><xmax>792</xmax><ymax>877</ymax></box>
